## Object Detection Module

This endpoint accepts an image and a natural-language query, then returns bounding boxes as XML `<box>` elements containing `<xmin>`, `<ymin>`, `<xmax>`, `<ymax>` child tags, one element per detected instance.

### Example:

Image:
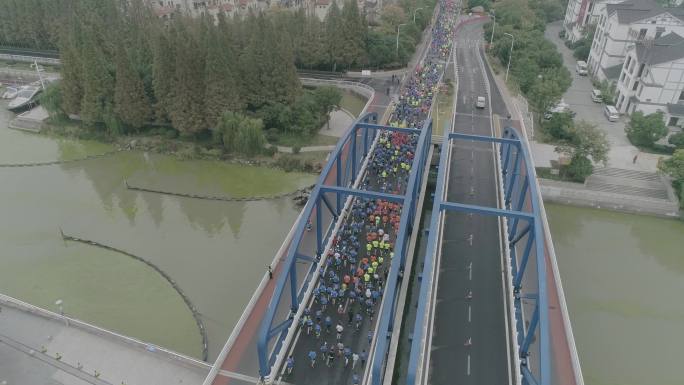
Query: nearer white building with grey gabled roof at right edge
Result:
<box><xmin>615</xmin><ymin>33</ymin><xmax>684</xmax><ymax>126</ymax></box>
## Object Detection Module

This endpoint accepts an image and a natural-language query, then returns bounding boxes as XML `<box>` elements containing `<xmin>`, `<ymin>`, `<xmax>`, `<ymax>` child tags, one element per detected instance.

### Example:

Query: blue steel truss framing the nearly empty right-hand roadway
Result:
<box><xmin>406</xmin><ymin>127</ymin><xmax>551</xmax><ymax>385</ymax></box>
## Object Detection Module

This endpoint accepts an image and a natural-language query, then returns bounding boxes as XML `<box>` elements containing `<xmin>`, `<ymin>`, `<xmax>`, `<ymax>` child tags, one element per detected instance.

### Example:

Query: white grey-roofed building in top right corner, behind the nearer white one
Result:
<box><xmin>587</xmin><ymin>0</ymin><xmax>684</xmax><ymax>81</ymax></box>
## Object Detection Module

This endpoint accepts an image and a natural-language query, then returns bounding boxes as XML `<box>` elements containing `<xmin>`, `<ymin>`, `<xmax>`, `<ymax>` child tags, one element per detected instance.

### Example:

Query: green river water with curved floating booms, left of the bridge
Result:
<box><xmin>0</xmin><ymin>105</ymin><xmax>315</xmax><ymax>359</ymax></box>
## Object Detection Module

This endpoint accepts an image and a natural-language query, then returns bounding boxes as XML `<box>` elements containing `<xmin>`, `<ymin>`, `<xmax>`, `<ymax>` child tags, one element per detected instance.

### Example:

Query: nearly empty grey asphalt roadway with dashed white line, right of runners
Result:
<box><xmin>429</xmin><ymin>20</ymin><xmax>512</xmax><ymax>385</ymax></box>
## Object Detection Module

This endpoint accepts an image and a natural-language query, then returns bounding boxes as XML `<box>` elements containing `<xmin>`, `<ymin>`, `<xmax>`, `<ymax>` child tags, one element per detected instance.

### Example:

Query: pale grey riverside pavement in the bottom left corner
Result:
<box><xmin>0</xmin><ymin>300</ymin><xmax>209</xmax><ymax>385</ymax></box>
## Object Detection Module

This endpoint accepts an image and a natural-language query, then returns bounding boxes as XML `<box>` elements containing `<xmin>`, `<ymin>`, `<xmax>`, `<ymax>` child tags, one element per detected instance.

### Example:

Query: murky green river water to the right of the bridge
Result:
<box><xmin>546</xmin><ymin>204</ymin><xmax>684</xmax><ymax>385</ymax></box>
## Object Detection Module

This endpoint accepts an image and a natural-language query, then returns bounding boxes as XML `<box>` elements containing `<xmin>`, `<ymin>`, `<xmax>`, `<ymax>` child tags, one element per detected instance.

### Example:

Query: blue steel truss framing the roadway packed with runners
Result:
<box><xmin>257</xmin><ymin>113</ymin><xmax>432</xmax><ymax>378</ymax></box>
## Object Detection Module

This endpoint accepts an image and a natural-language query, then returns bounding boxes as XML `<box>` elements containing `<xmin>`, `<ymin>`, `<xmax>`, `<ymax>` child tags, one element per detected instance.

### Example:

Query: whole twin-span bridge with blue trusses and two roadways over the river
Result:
<box><xmin>204</xmin><ymin>2</ymin><xmax>583</xmax><ymax>385</ymax></box>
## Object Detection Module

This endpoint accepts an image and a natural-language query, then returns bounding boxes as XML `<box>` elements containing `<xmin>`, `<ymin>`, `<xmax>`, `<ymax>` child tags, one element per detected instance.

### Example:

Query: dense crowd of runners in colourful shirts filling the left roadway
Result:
<box><xmin>285</xmin><ymin>0</ymin><xmax>455</xmax><ymax>385</ymax></box>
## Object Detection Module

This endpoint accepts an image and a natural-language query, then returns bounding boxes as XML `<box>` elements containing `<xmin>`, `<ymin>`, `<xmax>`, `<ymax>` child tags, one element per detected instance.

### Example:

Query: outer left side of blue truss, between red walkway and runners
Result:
<box><xmin>257</xmin><ymin>113</ymin><xmax>377</xmax><ymax>378</ymax></box>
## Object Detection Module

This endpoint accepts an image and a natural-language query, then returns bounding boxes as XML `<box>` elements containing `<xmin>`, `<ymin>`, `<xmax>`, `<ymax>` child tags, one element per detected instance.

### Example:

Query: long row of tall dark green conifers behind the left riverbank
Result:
<box><xmin>26</xmin><ymin>0</ymin><xmax>434</xmax><ymax>141</ymax></box>
